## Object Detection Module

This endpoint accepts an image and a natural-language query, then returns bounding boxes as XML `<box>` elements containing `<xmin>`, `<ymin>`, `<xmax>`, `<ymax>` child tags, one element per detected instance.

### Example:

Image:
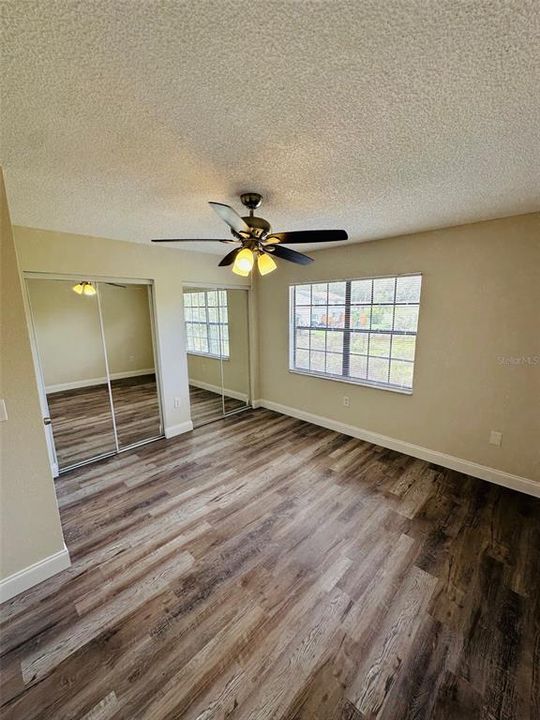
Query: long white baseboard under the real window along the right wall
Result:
<box><xmin>253</xmin><ymin>399</ymin><xmax>540</xmax><ymax>497</ymax></box>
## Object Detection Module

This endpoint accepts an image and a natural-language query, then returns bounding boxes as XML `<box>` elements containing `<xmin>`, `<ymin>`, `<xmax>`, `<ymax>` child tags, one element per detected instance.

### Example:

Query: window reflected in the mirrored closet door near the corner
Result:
<box><xmin>184</xmin><ymin>290</ymin><xmax>229</xmax><ymax>358</ymax></box>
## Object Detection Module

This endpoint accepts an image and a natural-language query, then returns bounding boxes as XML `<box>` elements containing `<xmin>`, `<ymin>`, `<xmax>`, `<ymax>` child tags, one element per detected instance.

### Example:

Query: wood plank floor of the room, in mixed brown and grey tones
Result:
<box><xmin>1</xmin><ymin>410</ymin><xmax>540</xmax><ymax>720</ymax></box>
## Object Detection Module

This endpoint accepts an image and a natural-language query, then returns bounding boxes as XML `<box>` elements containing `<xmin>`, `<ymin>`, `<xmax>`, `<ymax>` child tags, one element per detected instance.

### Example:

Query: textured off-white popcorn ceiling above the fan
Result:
<box><xmin>2</xmin><ymin>0</ymin><xmax>540</xmax><ymax>253</ymax></box>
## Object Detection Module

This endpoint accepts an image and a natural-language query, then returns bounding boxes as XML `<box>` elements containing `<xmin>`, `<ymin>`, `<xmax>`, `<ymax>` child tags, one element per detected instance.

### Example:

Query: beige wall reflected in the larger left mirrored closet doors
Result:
<box><xmin>26</xmin><ymin>278</ymin><xmax>154</xmax><ymax>392</ymax></box>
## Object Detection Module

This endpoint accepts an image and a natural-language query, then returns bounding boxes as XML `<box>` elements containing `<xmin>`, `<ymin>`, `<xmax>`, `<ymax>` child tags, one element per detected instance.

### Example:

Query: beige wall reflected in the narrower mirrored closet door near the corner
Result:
<box><xmin>188</xmin><ymin>290</ymin><xmax>249</xmax><ymax>399</ymax></box>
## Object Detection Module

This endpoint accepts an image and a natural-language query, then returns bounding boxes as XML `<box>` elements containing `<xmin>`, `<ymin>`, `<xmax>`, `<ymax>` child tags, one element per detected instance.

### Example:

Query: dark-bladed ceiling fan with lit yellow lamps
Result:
<box><xmin>152</xmin><ymin>192</ymin><xmax>349</xmax><ymax>277</ymax></box>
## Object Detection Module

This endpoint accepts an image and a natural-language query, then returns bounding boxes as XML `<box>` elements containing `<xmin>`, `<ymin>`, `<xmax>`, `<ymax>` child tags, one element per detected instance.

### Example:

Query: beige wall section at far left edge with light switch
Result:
<box><xmin>0</xmin><ymin>172</ymin><xmax>64</xmax><ymax>580</ymax></box>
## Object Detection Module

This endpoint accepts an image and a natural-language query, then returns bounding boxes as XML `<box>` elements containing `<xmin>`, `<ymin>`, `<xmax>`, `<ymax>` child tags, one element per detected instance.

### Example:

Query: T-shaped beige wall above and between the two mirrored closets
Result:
<box><xmin>13</xmin><ymin>226</ymin><xmax>249</xmax><ymax>434</ymax></box>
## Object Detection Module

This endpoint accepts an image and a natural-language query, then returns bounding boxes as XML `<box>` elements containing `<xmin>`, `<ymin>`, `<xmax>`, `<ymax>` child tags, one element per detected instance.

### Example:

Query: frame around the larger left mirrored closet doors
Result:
<box><xmin>23</xmin><ymin>271</ymin><xmax>165</xmax><ymax>477</ymax></box>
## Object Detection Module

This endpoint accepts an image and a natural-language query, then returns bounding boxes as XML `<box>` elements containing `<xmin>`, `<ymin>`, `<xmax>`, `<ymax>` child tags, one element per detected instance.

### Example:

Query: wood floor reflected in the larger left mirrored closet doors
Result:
<box><xmin>47</xmin><ymin>375</ymin><xmax>161</xmax><ymax>469</ymax></box>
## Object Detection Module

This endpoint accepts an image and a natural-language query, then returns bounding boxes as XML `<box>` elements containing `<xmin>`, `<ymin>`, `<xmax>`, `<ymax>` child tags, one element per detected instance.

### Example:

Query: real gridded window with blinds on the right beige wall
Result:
<box><xmin>289</xmin><ymin>275</ymin><xmax>422</xmax><ymax>392</ymax></box>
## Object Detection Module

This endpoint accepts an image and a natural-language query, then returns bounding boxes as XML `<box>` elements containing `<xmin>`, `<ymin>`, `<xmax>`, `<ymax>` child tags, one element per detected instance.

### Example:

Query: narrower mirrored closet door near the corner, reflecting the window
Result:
<box><xmin>184</xmin><ymin>287</ymin><xmax>251</xmax><ymax>427</ymax></box>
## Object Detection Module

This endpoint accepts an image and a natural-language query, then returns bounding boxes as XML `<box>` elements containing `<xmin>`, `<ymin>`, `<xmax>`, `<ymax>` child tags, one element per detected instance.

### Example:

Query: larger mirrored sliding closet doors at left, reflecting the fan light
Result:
<box><xmin>26</xmin><ymin>276</ymin><xmax>163</xmax><ymax>472</ymax></box>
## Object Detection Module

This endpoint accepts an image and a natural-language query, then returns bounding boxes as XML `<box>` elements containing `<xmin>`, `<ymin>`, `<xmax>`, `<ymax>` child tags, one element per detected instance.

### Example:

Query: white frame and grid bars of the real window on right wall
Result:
<box><xmin>289</xmin><ymin>272</ymin><xmax>422</xmax><ymax>395</ymax></box>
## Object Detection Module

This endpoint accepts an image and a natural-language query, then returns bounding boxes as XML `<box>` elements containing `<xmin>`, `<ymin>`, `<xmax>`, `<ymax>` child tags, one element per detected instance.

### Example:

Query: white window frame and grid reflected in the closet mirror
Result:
<box><xmin>183</xmin><ymin>288</ymin><xmax>230</xmax><ymax>360</ymax></box>
